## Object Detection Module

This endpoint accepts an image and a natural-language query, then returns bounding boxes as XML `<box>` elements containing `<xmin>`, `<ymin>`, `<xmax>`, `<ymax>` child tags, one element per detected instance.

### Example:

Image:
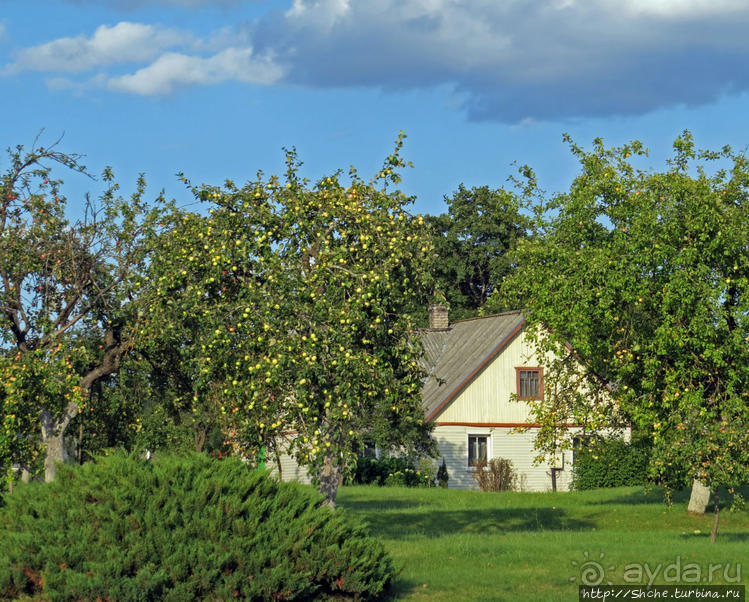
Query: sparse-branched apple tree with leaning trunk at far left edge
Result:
<box><xmin>0</xmin><ymin>138</ymin><xmax>165</xmax><ymax>480</ymax></box>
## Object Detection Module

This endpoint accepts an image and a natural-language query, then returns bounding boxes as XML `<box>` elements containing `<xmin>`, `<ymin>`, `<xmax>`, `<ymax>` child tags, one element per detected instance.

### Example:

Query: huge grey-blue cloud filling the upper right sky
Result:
<box><xmin>241</xmin><ymin>0</ymin><xmax>749</xmax><ymax>123</ymax></box>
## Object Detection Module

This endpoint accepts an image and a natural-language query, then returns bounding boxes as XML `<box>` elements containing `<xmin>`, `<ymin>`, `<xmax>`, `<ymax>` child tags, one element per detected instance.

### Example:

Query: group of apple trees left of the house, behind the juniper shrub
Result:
<box><xmin>0</xmin><ymin>134</ymin><xmax>432</xmax><ymax>505</ymax></box>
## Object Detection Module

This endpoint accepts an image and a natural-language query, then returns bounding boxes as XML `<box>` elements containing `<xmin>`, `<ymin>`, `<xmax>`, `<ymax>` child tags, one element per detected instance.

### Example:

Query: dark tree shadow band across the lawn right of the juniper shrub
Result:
<box><xmin>344</xmin><ymin>503</ymin><xmax>595</xmax><ymax>539</ymax></box>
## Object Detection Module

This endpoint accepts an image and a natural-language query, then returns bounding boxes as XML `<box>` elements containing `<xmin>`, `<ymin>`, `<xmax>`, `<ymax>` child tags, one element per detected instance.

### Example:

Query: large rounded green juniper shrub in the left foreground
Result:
<box><xmin>0</xmin><ymin>454</ymin><xmax>394</xmax><ymax>602</ymax></box>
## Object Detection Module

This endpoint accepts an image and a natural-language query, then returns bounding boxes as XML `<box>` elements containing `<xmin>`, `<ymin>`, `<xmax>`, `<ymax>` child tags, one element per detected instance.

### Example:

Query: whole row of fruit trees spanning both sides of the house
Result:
<box><xmin>0</xmin><ymin>133</ymin><xmax>749</xmax><ymax>516</ymax></box>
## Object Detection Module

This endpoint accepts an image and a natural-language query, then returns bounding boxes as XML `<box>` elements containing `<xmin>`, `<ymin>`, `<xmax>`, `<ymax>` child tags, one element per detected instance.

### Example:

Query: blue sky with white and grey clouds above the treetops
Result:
<box><xmin>0</xmin><ymin>0</ymin><xmax>749</xmax><ymax>214</ymax></box>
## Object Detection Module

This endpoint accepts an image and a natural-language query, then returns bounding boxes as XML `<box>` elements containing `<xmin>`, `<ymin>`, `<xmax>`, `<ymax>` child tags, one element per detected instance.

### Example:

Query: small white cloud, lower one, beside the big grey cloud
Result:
<box><xmin>107</xmin><ymin>48</ymin><xmax>283</xmax><ymax>96</ymax></box>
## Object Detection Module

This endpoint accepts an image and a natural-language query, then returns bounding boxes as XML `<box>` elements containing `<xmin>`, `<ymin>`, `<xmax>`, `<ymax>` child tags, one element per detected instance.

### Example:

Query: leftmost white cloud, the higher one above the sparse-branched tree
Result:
<box><xmin>5</xmin><ymin>21</ymin><xmax>187</xmax><ymax>73</ymax></box>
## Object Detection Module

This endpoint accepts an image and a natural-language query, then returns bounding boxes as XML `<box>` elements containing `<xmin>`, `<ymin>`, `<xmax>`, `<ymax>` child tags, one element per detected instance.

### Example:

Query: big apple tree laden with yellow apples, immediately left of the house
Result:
<box><xmin>147</xmin><ymin>134</ymin><xmax>432</xmax><ymax>503</ymax></box>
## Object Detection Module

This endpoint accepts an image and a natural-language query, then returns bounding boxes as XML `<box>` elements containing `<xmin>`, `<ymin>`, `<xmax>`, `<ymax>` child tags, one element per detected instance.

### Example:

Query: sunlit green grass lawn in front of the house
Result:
<box><xmin>338</xmin><ymin>486</ymin><xmax>749</xmax><ymax>602</ymax></box>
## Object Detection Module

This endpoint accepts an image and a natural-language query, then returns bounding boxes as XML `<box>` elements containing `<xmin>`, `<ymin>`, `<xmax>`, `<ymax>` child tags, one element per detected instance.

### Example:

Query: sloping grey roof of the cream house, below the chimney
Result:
<box><xmin>421</xmin><ymin>311</ymin><xmax>525</xmax><ymax>420</ymax></box>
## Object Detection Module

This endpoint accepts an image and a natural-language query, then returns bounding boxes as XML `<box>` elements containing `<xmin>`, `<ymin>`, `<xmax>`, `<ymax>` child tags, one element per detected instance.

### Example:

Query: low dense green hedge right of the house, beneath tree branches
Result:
<box><xmin>572</xmin><ymin>437</ymin><xmax>652</xmax><ymax>489</ymax></box>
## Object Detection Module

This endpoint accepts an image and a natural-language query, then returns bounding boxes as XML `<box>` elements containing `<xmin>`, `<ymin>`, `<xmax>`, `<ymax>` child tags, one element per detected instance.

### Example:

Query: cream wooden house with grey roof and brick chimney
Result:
<box><xmin>421</xmin><ymin>306</ymin><xmax>616</xmax><ymax>491</ymax></box>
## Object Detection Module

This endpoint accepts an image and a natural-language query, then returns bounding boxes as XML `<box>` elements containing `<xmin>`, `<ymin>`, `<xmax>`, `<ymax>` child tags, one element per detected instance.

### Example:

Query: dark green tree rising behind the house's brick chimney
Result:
<box><xmin>426</xmin><ymin>184</ymin><xmax>526</xmax><ymax>319</ymax></box>
